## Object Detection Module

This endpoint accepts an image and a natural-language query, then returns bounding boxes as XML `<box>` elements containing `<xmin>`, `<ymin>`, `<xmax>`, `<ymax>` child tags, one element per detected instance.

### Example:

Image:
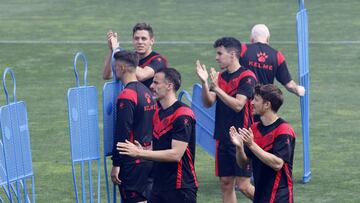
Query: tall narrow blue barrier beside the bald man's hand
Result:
<box><xmin>296</xmin><ymin>0</ymin><xmax>311</xmax><ymax>183</ymax></box>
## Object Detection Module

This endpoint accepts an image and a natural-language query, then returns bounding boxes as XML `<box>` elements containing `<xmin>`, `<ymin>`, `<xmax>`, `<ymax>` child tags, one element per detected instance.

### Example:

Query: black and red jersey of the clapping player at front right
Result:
<box><xmin>245</xmin><ymin>118</ymin><xmax>296</xmax><ymax>203</ymax></box>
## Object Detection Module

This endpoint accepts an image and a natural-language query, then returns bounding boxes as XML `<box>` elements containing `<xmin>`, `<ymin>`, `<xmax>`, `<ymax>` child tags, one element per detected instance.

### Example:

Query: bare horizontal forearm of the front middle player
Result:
<box><xmin>138</xmin><ymin>149</ymin><xmax>184</xmax><ymax>162</ymax></box>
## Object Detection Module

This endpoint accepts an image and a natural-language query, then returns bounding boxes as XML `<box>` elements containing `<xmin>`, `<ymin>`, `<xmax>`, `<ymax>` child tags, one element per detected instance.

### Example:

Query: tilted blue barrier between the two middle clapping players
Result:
<box><xmin>179</xmin><ymin>84</ymin><xmax>216</xmax><ymax>157</ymax></box>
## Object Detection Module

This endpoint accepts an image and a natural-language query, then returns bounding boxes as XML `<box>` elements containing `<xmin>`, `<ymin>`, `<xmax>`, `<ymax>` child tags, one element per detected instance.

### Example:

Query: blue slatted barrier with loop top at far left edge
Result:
<box><xmin>0</xmin><ymin>68</ymin><xmax>35</xmax><ymax>203</ymax></box>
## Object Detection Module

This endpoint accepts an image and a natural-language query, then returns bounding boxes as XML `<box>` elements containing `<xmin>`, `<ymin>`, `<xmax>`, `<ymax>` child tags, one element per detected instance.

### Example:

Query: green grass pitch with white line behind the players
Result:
<box><xmin>0</xmin><ymin>0</ymin><xmax>360</xmax><ymax>203</ymax></box>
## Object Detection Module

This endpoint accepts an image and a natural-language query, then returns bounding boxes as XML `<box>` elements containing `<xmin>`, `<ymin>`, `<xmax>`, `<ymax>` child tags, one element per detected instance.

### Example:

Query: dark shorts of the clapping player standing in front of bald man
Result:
<box><xmin>215</xmin><ymin>140</ymin><xmax>251</xmax><ymax>177</ymax></box>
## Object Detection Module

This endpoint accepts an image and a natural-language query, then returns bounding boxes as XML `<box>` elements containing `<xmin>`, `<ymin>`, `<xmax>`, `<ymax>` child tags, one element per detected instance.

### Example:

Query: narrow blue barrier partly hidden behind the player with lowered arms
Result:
<box><xmin>103</xmin><ymin>50</ymin><xmax>124</xmax><ymax>203</ymax></box>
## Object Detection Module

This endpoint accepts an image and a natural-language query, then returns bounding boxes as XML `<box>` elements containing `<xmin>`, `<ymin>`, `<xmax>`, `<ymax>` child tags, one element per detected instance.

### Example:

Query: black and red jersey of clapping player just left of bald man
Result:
<box><xmin>214</xmin><ymin>67</ymin><xmax>256</xmax><ymax>144</ymax></box>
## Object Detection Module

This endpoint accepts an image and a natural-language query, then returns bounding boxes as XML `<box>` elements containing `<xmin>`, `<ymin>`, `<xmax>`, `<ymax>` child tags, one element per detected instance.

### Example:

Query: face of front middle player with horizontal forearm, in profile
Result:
<box><xmin>150</xmin><ymin>73</ymin><xmax>172</xmax><ymax>101</ymax></box>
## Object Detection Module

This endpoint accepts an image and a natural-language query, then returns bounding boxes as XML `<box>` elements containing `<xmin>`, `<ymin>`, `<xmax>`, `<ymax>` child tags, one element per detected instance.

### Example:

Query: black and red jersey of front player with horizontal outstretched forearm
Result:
<box><xmin>153</xmin><ymin>101</ymin><xmax>198</xmax><ymax>191</ymax></box>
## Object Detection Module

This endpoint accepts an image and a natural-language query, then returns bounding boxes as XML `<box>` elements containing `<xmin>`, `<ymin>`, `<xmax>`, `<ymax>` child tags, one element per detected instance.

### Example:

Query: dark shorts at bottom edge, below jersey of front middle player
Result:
<box><xmin>148</xmin><ymin>188</ymin><xmax>197</xmax><ymax>203</ymax></box>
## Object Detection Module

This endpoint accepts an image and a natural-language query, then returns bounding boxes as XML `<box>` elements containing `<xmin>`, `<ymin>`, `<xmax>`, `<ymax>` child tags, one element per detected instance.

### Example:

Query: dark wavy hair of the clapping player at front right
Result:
<box><xmin>255</xmin><ymin>84</ymin><xmax>284</xmax><ymax>113</ymax></box>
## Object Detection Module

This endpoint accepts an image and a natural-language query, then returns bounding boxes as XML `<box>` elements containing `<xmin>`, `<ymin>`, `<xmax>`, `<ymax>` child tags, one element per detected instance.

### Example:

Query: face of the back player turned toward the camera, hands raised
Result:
<box><xmin>133</xmin><ymin>30</ymin><xmax>154</xmax><ymax>55</ymax></box>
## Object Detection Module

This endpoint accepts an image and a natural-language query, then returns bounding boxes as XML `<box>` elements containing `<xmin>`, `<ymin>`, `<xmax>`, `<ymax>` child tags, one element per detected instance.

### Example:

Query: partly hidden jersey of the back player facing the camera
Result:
<box><xmin>139</xmin><ymin>51</ymin><xmax>168</xmax><ymax>88</ymax></box>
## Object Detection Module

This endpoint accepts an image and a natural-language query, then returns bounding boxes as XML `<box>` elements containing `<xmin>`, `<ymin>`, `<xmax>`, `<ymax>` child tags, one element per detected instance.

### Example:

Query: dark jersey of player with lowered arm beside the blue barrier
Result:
<box><xmin>112</xmin><ymin>82</ymin><xmax>157</xmax><ymax>166</ymax></box>
